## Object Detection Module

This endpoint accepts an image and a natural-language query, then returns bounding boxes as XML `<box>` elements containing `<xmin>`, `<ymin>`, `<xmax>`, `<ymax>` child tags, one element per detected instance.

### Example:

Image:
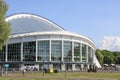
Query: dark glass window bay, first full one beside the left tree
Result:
<box><xmin>8</xmin><ymin>43</ymin><xmax>21</xmax><ymax>61</ymax></box>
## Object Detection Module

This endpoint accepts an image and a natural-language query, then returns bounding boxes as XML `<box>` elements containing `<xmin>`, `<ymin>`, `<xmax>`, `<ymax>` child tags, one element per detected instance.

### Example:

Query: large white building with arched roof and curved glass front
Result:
<box><xmin>0</xmin><ymin>14</ymin><xmax>100</xmax><ymax>70</ymax></box>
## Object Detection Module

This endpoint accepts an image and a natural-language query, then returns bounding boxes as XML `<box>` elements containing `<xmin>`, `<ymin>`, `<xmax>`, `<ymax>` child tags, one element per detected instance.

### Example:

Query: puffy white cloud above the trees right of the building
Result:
<box><xmin>100</xmin><ymin>36</ymin><xmax>120</xmax><ymax>51</ymax></box>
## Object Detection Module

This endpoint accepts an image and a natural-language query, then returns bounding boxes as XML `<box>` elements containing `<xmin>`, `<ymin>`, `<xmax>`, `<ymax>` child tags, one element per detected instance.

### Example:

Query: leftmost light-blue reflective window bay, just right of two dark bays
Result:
<box><xmin>37</xmin><ymin>41</ymin><xmax>49</xmax><ymax>61</ymax></box>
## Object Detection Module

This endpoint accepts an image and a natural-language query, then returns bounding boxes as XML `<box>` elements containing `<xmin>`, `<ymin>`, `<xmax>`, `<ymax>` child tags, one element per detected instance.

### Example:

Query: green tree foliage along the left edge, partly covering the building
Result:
<box><xmin>0</xmin><ymin>0</ymin><xmax>10</xmax><ymax>50</ymax></box>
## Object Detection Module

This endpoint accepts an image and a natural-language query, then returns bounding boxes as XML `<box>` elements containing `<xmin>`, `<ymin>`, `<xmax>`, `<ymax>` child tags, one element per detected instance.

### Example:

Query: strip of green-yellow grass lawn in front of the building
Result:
<box><xmin>0</xmin><ymin>72</ymin><xmax>120</xmax><ymax>80</ymax></box>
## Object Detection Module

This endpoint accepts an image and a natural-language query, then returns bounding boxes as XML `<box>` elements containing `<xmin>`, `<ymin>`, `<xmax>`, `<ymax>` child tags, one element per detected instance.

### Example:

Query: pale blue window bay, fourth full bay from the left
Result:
<box><xmin>51</xmin><ymin>41</ymin><xmax>62</xmax><ymax>61</ymax></box>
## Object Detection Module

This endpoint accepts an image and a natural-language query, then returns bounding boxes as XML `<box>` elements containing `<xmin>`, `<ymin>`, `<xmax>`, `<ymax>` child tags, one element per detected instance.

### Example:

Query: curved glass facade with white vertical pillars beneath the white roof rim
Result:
<box><xmin>0</xmin><ymin>40</ymin><xmax>93</xmax><ymax>70</ymax></box>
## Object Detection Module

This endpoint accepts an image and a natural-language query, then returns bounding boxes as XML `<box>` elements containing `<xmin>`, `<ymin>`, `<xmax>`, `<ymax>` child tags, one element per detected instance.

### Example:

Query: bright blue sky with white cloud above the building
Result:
<box><xmin>5</xmin><ymin>0</ymin><xmax>120</xmax><ymax>50</ymax></box>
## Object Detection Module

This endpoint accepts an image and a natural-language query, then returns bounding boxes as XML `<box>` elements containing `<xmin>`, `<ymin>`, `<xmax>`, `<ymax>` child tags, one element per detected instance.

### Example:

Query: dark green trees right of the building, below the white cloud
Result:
<box><xmin>96</xmin><ymin>49</ymin><xmax>120</xmax><ymax>65</ymax></box>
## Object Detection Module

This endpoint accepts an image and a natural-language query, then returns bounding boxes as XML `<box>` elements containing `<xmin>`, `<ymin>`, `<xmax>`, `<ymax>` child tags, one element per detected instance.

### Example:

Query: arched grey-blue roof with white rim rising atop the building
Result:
<box><xmin>6</xmin><ymin>14</ymin><xmax>64</xmax><ymax>34</ymax></box>
